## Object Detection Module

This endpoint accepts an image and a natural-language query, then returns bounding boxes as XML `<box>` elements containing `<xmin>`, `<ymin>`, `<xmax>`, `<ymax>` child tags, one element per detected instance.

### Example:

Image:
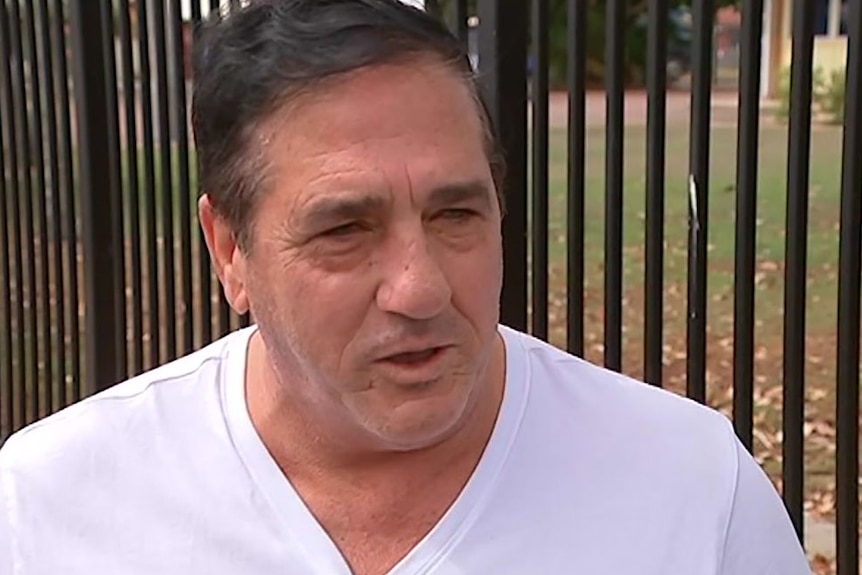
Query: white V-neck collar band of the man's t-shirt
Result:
<box><xmin>222</xmin><ymin>326</ymin><xmax>530</xmax><ymax>575</ymax></box>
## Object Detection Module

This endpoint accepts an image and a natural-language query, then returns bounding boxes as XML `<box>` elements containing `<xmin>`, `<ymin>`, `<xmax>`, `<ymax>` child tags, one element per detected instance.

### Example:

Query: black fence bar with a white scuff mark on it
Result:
<box><xmin>686</xmin><ymin>0</ymin><xmax>715</xmax><ymax>403</ymax></box>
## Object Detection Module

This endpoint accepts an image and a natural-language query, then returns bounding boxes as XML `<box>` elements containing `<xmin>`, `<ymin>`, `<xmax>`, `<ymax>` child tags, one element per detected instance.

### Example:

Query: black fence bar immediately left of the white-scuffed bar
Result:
<box><xmin>644</xmin><ymin>0</ymin><xmax>668</xmax><ymax>392</ymax></box>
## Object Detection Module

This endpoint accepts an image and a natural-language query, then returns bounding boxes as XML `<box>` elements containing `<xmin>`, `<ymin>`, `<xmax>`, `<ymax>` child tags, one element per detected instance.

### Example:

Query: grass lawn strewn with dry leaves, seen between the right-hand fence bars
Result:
<box><xmin>549</xmin><ymin>124</ymin><xmax>852</xmax><ymax>528</ymax></box>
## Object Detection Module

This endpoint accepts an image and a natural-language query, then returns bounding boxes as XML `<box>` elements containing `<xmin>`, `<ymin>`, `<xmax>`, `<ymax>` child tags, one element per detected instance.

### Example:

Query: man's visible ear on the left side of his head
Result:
<box><xmin>198</xmin><ymin>194</ymin><xmax>249</xmax><ymax>315</ymax></box>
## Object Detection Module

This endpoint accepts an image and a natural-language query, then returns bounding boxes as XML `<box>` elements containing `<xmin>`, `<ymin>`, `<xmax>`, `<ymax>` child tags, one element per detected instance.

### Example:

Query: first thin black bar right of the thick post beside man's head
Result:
<box><xmin>531</xmin><ymin>0</ymin><xmax>548</xmax><ymax>340</ymax></box>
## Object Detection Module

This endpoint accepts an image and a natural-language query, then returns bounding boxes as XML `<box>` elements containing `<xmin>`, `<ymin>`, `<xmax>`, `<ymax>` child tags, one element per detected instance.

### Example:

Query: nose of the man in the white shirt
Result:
<box><xmin>376</xmin><ymin>235</ymin><xmax>452</xmax><ymax>320</ymax></box>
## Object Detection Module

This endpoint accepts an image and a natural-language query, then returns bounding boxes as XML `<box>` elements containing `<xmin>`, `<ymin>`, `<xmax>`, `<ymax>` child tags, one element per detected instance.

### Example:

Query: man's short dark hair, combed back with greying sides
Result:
<box><xmin>192</xmin><ymin>0</ymin><xmax>503</xmax><ymax>248</ymax></box>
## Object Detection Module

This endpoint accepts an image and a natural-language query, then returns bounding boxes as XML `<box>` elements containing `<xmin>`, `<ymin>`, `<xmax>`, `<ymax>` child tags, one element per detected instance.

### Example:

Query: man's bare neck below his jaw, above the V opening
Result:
<box><xmin>246</xmin><ymin>333</ymin><xmax>505</xmax><ymax>486</ymax></box>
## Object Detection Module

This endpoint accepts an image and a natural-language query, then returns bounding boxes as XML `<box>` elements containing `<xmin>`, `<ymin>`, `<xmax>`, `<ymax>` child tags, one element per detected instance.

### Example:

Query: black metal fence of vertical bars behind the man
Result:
<box><xmin>0</xmin><ymin>0</ymin><xmax>862</xmax><ymax>575</ymax></box>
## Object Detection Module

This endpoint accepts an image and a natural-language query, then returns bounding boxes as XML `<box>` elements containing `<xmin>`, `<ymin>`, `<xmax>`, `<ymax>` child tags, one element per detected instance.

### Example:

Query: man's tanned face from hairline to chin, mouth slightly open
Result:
<box><xmin>213</xmin><ymin>63</ymin><xmax>502</xmax><ymax>449</ymax></box>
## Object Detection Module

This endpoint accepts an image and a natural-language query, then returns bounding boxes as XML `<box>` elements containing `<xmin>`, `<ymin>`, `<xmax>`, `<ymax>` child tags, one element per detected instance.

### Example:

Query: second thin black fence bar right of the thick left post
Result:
<box><xmin>136</xmin><ymin>1</ymin><xmax>162</xmax><ymax>368</ymax></box>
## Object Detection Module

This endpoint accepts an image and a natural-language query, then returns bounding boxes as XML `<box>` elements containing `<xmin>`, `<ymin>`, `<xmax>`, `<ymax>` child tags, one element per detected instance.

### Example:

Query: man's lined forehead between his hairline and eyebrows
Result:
<box><xmin>254</xmin><ymin>63</ymin><xmax>490</xmax><ymax>223</ymax></box>
